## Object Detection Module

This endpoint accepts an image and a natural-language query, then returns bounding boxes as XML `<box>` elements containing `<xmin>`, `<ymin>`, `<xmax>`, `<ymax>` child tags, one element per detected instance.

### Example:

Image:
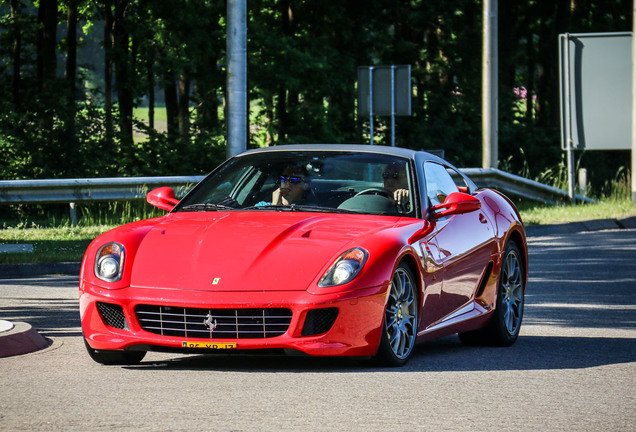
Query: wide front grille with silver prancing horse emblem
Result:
<box><xmin>135</xmin><ymin>305</ymin><xmax>292</xmax><ymax>339</ymax></box>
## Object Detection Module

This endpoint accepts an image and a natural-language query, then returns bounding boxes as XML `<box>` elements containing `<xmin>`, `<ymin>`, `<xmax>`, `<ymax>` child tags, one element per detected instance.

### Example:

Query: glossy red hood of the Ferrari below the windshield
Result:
<box><xmin>130</xmin><ymin>211</ymin><xmax>399</xmax><ymax>291</ymax></box>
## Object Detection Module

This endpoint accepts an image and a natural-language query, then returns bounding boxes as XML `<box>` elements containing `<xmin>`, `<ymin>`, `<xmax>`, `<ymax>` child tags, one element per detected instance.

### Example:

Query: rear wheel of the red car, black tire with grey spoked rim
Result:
<box><xmin>459</xmin><ymin>240</ymin><xmax>526</xmax><ymax>346</ymax></box>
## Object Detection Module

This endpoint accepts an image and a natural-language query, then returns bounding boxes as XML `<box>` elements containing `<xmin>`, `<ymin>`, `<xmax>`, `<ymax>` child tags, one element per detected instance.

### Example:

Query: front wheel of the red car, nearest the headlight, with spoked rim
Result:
<box><xmin>374</xmin><ymin>263</ymin><xmax>418</xmax><ymax>367</ymax></box>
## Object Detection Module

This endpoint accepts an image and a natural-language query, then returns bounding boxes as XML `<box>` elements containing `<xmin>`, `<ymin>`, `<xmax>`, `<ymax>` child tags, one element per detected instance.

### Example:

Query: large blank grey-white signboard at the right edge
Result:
<box><xmin>559</xmin><ymin>33</ymin><xmax>632</xmax><ymax>150</ymax></box>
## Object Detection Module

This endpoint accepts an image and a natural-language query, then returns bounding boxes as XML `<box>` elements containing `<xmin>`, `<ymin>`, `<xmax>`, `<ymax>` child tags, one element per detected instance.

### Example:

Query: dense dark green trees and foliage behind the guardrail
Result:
<box><xmin>0</xmin><ymin>0</ymin><xmax>632</xmax><ymax>192</ymax></box>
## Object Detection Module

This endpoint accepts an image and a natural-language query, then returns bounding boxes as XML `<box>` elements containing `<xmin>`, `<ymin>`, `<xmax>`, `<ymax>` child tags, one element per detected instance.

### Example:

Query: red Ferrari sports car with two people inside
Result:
<box><xmin>79</xmin><ymin>145</ymin><xmax>527</xmax><ymax>366</ymax></box>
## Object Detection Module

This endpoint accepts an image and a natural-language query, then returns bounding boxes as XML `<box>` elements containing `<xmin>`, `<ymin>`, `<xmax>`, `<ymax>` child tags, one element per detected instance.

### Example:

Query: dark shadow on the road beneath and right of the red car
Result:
<box><xmin>126</xmin><ymin>336</ymin><xmax>636</xmax><ymax>373</ymax></box>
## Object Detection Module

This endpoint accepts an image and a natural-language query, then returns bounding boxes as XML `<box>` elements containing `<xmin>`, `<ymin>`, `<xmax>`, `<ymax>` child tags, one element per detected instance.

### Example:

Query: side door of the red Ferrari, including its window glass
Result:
<box><xmin>424</xmin><ymin>162</ymin><xmax>494</xmax><ymax>325</ymax></box>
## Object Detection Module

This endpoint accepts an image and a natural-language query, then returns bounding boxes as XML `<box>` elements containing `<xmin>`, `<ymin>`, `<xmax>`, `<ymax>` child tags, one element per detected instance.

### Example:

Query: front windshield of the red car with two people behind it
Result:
<box><xmin>175</xmin><ymin>151</ymin><xmax>416</xmax><ymax>216</ymax></box>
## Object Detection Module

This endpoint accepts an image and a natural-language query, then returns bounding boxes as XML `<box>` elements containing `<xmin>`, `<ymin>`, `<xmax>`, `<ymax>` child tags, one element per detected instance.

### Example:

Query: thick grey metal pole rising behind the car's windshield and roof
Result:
<box><xmin>227</xmin><ymin>0</ymin><xmax>248</xmax><ymax>158</ymax></box>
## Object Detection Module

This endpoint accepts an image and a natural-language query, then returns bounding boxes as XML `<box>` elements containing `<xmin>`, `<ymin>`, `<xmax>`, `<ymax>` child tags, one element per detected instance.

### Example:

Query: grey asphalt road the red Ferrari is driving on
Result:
<box><xmin>0</xmin><ymin>230</ymin><xmax>636</xmax><ymax>431</ymax></box>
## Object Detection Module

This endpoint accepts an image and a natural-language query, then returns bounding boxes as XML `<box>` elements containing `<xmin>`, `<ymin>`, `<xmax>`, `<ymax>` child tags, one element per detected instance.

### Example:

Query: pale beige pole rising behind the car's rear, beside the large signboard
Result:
<box><xmin>481</xmin><ymin>0</ymin><xmax>499</xmax><ymax>168</ymax></box>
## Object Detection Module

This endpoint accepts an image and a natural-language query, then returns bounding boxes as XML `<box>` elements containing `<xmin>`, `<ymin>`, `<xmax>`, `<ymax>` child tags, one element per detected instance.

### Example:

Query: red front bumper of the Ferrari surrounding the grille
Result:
<box><xmin>80</xmin><ymin>280</ymin><xmax>388</xmax><ymax>356</ymax></box>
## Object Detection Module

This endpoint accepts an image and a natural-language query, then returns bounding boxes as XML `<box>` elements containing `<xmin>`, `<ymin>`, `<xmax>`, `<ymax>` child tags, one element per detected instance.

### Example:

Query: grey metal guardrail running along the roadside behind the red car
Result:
<box><xmin>0</xmin><ymin>168</ymin><xmax>593</xmax><ymax>207</ymax></box>
